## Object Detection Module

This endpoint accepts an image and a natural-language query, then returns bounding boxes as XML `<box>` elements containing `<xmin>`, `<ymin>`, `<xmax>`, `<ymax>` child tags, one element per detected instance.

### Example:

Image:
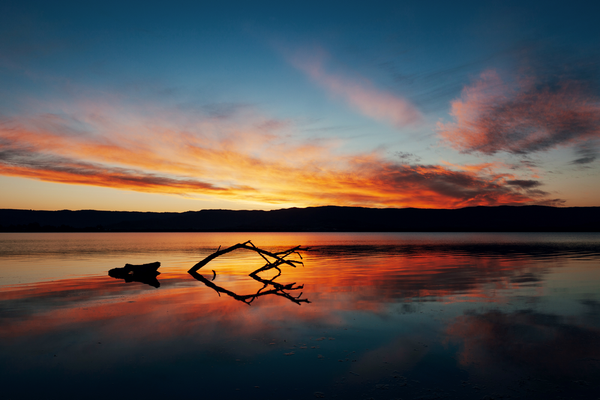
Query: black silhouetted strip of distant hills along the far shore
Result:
<box><xmin>0</xmin><ymin>206</ymin><xmax>600</xmax><ymax>232</ymax></box>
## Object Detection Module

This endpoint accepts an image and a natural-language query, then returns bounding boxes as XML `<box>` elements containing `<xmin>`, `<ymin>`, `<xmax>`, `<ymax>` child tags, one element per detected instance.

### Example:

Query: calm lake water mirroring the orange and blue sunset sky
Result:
<box><xmin>0</xmin><ymin>233</ymin><xmax>600</xmax><ymax>400</ymax></box>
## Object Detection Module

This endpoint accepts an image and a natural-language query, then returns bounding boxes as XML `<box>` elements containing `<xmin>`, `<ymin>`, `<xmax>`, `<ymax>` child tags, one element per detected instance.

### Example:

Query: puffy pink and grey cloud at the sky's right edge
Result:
<box><xmin>438</xmin><ymin>71</ymin><xmax>600</xmax><ymax>154</ymax></box>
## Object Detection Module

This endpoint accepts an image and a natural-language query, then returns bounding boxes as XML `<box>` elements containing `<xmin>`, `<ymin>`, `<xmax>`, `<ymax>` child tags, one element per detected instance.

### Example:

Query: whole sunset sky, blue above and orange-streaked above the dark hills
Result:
<box><xmin>0</xmin><ymin>0</ymin><xmax>600</xmax><ymax>211</ymax></box>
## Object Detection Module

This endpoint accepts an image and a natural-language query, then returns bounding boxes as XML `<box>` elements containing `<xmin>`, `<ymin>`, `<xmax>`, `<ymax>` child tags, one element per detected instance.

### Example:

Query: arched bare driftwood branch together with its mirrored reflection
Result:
<box><xmin>188</xmin><ymin>240</ymin><xmax>310</xmax><ymax>305</ymax></box>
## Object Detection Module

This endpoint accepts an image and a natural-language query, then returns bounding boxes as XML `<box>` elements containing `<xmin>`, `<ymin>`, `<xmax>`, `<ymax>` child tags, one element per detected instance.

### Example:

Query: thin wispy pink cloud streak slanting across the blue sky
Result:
<box><xmin>289</xmin><ymin>49</ymin><xmax>422</xmax><ymax>128</ymax></box>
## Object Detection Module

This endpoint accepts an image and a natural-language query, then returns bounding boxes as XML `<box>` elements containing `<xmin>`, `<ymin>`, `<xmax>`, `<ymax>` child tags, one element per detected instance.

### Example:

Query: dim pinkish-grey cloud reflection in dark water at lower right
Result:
<box><xmin>446</xmin><ymin>310</ymin><xmax>600</xmax><ymax>380</ymax></box>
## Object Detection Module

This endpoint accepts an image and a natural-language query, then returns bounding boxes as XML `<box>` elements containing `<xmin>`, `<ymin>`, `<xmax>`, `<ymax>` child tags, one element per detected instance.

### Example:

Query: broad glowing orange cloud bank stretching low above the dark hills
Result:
<box><xmin>0</xmin><ymin>98</ymin><xmax>564</xmax><ymax>208</ymax></box>
